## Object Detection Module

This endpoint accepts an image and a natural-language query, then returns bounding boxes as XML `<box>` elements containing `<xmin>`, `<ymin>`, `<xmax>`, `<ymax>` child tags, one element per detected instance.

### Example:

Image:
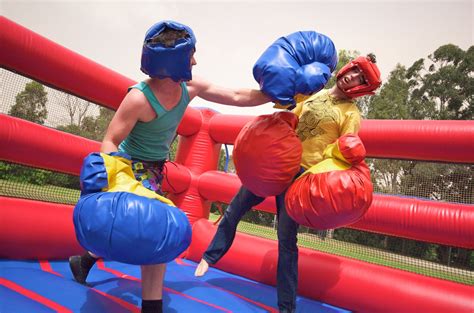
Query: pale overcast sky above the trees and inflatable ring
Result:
<box><xmin>0</xmin><ymin>0</ymin><xmax>474</xmax><ymax>115</ymax></box>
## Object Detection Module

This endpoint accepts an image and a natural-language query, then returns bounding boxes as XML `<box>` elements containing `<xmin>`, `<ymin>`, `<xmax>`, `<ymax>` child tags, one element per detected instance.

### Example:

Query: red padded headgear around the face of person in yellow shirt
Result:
<box><xmin>336</xmin><ymin>56</ymin><xmax>382</xmax><ymax>98</ymax></box>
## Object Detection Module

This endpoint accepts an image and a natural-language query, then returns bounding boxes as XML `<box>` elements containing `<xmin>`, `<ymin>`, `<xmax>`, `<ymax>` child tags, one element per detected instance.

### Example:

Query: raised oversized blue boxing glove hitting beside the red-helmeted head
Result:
<box><xmin>253</xmin><ymin>31</ymin><xmax>337</xmax><ymax>104</ymax></box>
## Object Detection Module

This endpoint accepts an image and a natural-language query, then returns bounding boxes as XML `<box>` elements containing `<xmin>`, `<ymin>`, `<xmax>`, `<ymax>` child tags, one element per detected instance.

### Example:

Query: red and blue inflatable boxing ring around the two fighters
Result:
<box><xmin>0</xmin><ymin>17</ymin><xmax>474</xmax><ymax>312</ymax></box>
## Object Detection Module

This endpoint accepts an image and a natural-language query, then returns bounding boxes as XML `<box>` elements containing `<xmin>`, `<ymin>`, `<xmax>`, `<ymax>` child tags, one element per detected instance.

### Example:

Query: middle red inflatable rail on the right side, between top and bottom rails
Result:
<box><xmin>199</xmin><ymin>171</ymin><xmax>474</xmax><ymax>249</ymax></box>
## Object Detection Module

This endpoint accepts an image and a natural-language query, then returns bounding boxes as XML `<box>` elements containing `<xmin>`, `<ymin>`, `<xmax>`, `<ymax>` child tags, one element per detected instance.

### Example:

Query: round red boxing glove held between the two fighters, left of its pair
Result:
<box><xmin>233</xmin><ymin>112</ymin><xmax>303</xmax><ymax>197</ymax></box>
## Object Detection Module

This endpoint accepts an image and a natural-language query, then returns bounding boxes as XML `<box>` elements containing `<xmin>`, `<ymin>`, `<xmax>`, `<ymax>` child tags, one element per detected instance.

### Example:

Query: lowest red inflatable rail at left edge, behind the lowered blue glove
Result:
<box><xmin>0</xmin><ymin>197</ymin><xmax>84</xmax><ymax>260</ymax></box>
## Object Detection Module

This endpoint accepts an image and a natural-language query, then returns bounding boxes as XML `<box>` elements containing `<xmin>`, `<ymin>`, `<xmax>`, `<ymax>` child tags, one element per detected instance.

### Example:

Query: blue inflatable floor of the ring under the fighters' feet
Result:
<box><xmin>0</xmin><ymin>260</ymin><xmax>349</xmax><ymax>313</ymax></box>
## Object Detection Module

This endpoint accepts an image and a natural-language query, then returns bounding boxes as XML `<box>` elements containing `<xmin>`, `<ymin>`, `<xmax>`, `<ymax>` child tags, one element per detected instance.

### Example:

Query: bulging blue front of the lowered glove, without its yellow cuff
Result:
<box><xmin>73</xmin><ymin>192</ymin><xmax>191</xmax><ymax>265</ymax></box>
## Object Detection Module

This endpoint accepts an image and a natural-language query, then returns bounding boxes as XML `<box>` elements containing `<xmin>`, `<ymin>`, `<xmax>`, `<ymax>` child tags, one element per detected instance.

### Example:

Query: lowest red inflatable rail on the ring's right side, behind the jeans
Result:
<box><xmin>187</xmin><ymin>219</ymin><xmax>474</xmax><ymax>313</ymax></box>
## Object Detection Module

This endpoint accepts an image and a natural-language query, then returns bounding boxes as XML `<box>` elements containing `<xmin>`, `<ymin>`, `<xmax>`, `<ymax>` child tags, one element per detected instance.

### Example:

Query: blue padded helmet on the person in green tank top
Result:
<box><xmin>140</xmin><ymin>21</ymin><xmax>196</xmax><ymax>82</ymax></box>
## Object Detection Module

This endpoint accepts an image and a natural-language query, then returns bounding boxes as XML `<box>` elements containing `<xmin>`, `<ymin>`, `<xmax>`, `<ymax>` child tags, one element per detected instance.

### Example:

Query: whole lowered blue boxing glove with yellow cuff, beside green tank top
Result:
<box><xmin>73</xmin><ymin>152</ymin><xmax>191</xmax><ymax>265</ymax></box>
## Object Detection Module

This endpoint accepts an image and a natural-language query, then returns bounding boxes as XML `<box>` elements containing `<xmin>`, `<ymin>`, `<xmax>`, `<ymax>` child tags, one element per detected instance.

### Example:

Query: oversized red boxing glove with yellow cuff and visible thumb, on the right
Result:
<box><xmin>285</xmin><ymin>135</ymin><xmax>373</xmax><ymax>229</ymax></box>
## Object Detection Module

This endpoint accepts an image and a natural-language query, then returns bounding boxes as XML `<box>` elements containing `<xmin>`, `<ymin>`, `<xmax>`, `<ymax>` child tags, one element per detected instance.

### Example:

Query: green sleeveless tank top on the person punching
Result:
<box><xmin>118</xmin><ymin>82</ymin><xmax>190</xmax><ymax>161</ymax></box>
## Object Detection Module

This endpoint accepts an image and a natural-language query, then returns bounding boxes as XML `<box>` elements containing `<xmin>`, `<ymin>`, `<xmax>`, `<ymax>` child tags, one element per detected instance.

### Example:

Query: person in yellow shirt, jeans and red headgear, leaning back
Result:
<box><xmin>195</xmin><ymin>56</ymin><xmax>381</xmax><ymax>312</ymax></box>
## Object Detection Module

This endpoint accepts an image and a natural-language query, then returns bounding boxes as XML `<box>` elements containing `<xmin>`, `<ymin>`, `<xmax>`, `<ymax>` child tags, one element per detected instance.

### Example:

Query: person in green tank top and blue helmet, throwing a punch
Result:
<box><xmin>70</xmin><ymin>21</ymin><xmax>271</xmax><ymax>313</ymax></box>
